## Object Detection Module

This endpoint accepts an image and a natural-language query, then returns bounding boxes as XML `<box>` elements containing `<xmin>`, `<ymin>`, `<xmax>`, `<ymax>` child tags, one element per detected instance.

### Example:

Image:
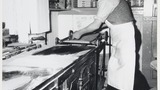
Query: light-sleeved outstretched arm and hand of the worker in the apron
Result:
<box><xmin>73</xmin><ymin>0</ymin><xmax>120</xmax><ymax>39</ymax></box>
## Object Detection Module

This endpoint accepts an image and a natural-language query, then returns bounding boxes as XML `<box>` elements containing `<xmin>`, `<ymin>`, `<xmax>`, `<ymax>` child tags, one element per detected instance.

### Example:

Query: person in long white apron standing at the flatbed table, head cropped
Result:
<box><xmin>72</xmin><ymin>0</ymin><xmax>149</xmax><ymax>90</ymax></box>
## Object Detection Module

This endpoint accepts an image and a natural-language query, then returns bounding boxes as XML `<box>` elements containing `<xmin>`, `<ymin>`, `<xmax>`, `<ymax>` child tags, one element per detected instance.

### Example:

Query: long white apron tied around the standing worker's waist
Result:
<box><xmin>105</xmin><ymin>20</ymin><xmax>135</xmax><ymax>90</ymax></box>
